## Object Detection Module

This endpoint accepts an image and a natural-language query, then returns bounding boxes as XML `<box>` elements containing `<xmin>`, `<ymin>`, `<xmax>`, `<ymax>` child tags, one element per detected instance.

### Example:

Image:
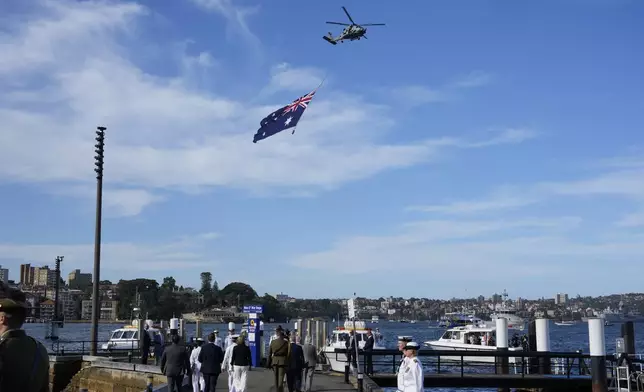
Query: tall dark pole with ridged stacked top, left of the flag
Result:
<box><xmin>90</xmin><ymin>127</ymin><xmax>107</xmax><ymax>355</ymax></box>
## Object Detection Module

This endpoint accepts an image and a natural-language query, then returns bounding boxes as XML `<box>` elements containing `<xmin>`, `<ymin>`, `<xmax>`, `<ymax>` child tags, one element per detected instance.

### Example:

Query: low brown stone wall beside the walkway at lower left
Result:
<box><xmin>49</xmin><ymin>356</ymin><xmax>166</xmax><ymax>392</ymax></box>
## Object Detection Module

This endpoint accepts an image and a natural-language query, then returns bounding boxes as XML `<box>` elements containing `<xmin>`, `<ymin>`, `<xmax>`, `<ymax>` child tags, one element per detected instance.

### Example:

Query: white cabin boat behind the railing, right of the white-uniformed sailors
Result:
<box><xmin>424</xmin><ymin>324</ymin><xmax>523</xmax><ymax>363</ymax></box>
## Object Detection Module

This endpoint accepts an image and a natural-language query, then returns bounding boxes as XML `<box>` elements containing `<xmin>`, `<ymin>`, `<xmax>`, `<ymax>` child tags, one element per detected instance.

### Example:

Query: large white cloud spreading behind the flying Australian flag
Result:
<box><xmin>0</xmin><ymin>1</ymin><xmax>527</xmax><ymax>216</ymax></box>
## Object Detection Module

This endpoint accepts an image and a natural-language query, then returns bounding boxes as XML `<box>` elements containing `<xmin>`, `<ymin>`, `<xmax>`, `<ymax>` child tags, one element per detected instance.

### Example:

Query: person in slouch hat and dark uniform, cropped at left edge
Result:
<box><xmin>0</xmin><ymin>282</ymin><xmax>49</xmax><ymax>392</ymax></box>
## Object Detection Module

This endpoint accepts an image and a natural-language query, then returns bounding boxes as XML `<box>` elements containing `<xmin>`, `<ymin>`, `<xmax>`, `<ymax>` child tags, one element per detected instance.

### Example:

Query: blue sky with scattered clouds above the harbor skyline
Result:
<box><xmin>0</xmin><ymin>0</ymin><xmax>644</xmax><ymax>298</ymax></box>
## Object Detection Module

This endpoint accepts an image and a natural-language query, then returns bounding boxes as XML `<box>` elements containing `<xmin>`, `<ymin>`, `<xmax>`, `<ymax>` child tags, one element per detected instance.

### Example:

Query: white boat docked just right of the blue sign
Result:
<box><xmin>322</xmin><ymin>321</ymin><xmax>385</xmax><ymax>373</ymax></box>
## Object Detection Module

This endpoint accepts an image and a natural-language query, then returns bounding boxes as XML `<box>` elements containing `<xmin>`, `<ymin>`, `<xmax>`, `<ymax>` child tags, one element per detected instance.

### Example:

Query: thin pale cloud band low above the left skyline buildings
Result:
<box><xmin>0</xmin><ymin>233</ymin><xmax>217</xmax><ymax>279</ymax></box>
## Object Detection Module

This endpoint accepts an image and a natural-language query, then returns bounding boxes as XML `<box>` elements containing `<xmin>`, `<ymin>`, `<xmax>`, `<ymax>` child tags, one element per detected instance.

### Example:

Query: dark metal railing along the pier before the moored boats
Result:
<box><xmin>335</xmin><ymin>349</ymin><xmax>616</xmax><ymax>378</ymax></box>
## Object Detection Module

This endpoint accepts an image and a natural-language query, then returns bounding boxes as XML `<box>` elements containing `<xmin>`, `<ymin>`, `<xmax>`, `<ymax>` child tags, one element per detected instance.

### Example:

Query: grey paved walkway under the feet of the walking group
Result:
<box><xmin>177</xmin><ymin>368</ymin><xmax>355</xmax><ymax>392</ymax></box>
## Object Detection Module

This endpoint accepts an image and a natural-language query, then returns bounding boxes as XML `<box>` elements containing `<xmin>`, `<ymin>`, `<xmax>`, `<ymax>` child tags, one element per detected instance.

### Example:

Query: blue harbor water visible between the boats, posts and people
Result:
<box><xmin>24</xmin><ymin>322</ymin><xmax>644</xmax><ymax>392</ymax></box>
